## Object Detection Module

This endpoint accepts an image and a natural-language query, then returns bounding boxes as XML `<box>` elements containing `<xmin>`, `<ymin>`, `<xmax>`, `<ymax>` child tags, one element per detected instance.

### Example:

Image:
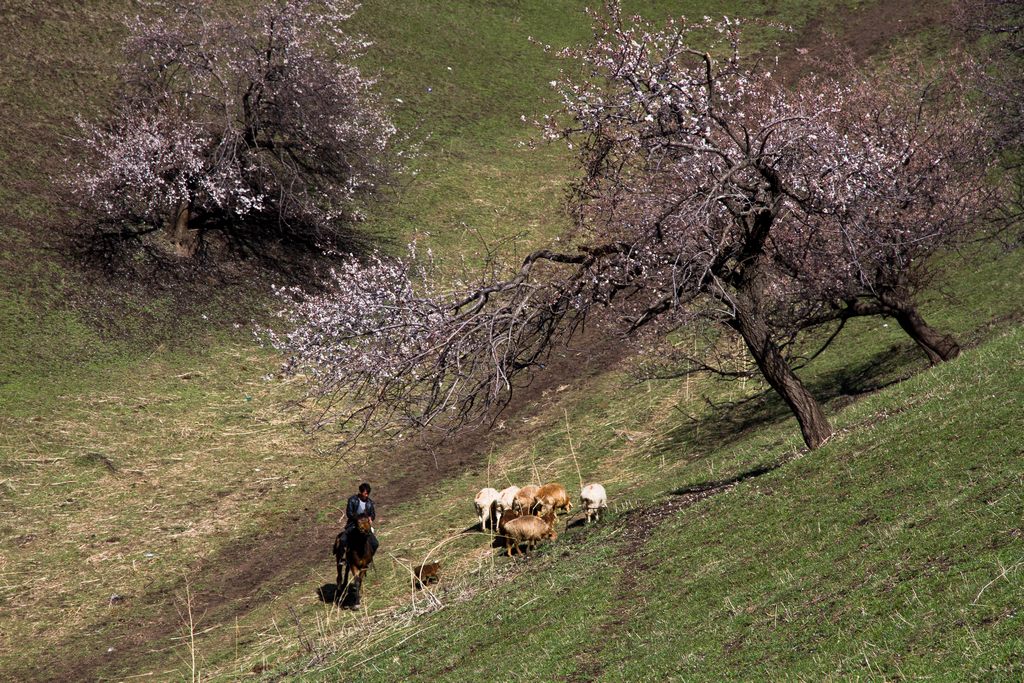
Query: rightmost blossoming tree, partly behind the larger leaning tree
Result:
<box><xmin>775</xmin><ymin>61</ymin><xmax>999</xmax><ymax>364</ymax></box>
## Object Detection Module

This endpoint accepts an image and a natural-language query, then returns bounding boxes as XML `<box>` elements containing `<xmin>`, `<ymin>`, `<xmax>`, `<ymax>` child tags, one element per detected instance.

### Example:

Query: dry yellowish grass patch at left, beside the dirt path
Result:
<box><xmin>0</xmin><ymin>347</ymin><xmax>342</xmax><ymax>671</ymax></box>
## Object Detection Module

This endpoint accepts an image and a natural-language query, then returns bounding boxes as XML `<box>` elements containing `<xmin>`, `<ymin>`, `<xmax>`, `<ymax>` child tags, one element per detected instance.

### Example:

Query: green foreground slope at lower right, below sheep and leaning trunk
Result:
<box><xmin>243</xmin><ymin>317</ymin><xmax>1024</xmax><ymax>681</ymax></box>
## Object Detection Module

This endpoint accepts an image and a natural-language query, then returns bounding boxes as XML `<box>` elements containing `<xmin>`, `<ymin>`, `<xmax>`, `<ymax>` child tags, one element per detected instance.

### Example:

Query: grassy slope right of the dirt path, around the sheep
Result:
<box><xmin>123</xmin><ymin>239</ymin><xmax>1024</xmax><ymax>680</ymax></box>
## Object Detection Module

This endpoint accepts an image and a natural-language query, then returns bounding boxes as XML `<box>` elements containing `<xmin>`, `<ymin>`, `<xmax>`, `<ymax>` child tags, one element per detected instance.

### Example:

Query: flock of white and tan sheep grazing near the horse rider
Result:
<box><xmin>473</xmin><ymin>483</ymin><xmax>608</xmax><ymax>557</ymax></box>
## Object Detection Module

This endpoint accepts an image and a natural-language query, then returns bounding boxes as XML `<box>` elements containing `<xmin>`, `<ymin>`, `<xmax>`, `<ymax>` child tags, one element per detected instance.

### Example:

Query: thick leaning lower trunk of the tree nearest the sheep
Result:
<box><xmin>732</xmin><ymin>296</ymin><xmax>833</xmax><ymax>450</ymax></box>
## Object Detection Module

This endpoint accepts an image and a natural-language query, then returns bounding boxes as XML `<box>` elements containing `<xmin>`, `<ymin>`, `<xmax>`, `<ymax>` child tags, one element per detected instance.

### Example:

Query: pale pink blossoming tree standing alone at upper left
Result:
<box><xmin>73</xmin><ymin>0</ymin><xmax>394</xmax><ymax>256</ymax></box>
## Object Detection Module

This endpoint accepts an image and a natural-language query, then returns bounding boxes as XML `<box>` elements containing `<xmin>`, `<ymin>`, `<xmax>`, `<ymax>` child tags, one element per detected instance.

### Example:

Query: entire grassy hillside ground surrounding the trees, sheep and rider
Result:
<box><xmin>0</xmin><ymin>0</ymin><xmax>1024</xmax><ymax>680</ymax></box>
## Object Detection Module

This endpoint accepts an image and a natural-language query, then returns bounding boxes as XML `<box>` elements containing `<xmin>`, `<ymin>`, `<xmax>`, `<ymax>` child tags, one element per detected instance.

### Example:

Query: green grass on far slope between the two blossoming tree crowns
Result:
<box><xmin>353</xmin><ymin>0</ymin><xmax>842</xmax><ymax>262</ymax></box>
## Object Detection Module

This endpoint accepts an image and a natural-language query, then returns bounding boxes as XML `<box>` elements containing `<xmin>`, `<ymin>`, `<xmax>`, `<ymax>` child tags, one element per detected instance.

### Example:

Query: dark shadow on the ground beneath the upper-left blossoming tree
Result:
<box><xmin>58</xmin><ymin>210</ymin><xmax>389</xmax><ymax>343</ymax></box>
